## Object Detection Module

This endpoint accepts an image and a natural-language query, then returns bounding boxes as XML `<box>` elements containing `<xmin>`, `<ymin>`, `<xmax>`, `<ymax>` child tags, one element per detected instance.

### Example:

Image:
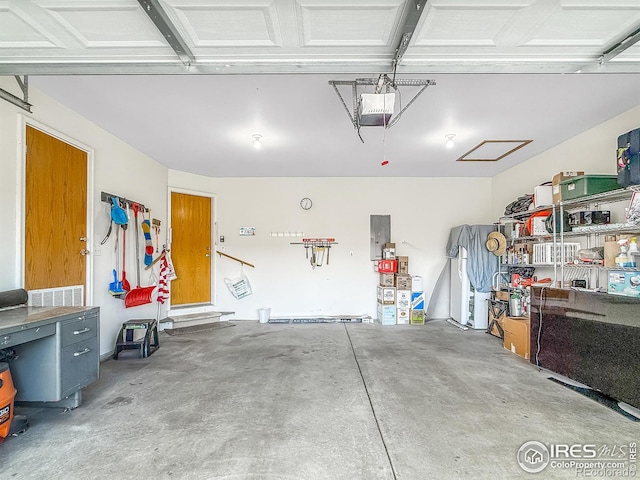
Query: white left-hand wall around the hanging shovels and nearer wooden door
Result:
<box><xmin>0</xmin><ymin>77</ymin><xmax>167</xmax><ymax>354</ymax></box>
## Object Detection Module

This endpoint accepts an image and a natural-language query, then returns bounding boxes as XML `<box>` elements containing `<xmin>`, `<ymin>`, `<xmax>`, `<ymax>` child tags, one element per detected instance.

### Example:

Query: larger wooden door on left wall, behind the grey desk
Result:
<box><xmin>25</xmin><ymin>126</ymin><xmax>88</xmax><ymax>290</ymax></box>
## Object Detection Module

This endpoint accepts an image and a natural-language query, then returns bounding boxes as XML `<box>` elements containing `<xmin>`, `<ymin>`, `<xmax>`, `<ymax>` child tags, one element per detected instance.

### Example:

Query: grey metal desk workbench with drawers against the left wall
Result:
<box><xmin>0</xmin><ymin>307</ymin><xmax>100</xmax><ymax>408</ymax></box>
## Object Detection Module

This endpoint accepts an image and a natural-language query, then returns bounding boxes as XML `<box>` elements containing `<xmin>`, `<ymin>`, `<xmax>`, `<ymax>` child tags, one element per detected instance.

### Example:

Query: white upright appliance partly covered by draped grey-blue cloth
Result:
<box><xmin>449</xmin><ymin>247</ymin><xmax>491</xmax><ymax>330</ymax></box>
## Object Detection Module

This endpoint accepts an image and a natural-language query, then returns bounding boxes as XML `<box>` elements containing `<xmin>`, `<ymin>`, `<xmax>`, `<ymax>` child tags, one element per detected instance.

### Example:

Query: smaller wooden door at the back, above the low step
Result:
<box><xmin>171</xmin><ymin>192</ymin><xmax>211</xmax><ymax>305</ymax></box>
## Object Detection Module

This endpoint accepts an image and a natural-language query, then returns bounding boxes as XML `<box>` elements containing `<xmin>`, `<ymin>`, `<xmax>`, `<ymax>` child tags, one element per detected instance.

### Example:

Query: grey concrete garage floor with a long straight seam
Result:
<box><xmin>0</xmin><ymin>321</ymin><xmax>640</xmax><ymax>480</ymax></box>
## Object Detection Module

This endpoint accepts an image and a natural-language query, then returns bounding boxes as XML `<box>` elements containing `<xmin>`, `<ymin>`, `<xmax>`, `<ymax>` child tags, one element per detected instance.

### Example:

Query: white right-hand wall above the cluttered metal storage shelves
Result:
<box><xmin>492</xmin><ymin>107</ymin><xmax>640</xmax><ymax>219</ymax></box>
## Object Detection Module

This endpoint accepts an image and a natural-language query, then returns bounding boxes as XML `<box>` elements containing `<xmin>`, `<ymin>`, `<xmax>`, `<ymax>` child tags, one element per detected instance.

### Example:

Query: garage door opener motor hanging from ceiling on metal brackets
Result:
<box><xmin>329</xmin><ymin>74</ymin><xmax>436</xmax><ymax>143</ymax></box>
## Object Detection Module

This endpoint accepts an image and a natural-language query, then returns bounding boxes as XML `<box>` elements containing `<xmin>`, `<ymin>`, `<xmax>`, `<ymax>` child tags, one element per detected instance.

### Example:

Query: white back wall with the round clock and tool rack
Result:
<box><xmin>169</xmin><ymin>170</ymin><xmax>493</xmax><ymax>319</ymax></box>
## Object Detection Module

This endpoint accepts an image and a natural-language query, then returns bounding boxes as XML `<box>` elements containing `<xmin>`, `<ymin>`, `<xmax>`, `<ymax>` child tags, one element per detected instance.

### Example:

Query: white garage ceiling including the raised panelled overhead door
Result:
<box><xmin>0</xmin><ymin>0</ymin><xmax>640</xmax><ymax>176</ymax></box>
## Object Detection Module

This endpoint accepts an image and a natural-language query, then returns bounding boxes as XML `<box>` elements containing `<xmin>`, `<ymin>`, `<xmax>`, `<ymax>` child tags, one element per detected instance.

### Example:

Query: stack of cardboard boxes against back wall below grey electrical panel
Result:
<box><xmin>377</xmin><ymin>243</ymin><xmax>425</xmax><ymax>325</ymax></box>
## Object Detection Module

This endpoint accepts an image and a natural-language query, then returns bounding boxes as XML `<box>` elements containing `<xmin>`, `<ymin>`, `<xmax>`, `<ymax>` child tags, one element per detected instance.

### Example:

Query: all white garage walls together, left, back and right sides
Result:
<box><xmin>5</xmin><ymin>77</ymin><xmax>640</xmax><ymax>354</ymax></box>
